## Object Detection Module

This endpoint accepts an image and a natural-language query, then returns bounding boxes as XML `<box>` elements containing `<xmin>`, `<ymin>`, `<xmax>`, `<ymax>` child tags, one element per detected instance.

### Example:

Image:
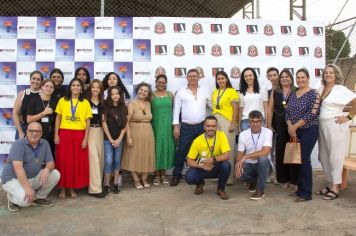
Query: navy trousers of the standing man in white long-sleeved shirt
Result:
<box><xmin>173</xmin><ymin>123</ymin><xmax>204</xmax><ymax>178</ymax></box>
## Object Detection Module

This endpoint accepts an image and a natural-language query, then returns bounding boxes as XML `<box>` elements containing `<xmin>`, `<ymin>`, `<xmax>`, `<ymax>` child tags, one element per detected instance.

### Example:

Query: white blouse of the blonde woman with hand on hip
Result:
<box><xmin>319</xmin><ymin>84</ymin><xmax>356</xmax><ymax>118</ymax></box>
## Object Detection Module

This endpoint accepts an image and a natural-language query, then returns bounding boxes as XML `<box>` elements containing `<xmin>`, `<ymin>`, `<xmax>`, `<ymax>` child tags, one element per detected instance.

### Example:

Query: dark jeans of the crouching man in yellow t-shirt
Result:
<box><xmin>185</xmin><ymin>161</ymin><xmax>231</xmax><ymax>191</ymax></box>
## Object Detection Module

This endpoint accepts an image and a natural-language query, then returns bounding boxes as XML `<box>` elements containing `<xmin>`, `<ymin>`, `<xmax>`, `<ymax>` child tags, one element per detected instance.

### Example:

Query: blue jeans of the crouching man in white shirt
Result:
<box><xmin>240</xmin><ymin>157</ymin><xmax>272</xmax><ymax>191</ymax></box>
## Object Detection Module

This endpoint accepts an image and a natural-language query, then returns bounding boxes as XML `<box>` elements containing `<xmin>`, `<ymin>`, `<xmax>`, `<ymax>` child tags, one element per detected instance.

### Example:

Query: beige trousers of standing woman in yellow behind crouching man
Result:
<box><xmin>214</xmin><ymin>114</ymin><xmax>236</xmax><ymax>184</ymax></box>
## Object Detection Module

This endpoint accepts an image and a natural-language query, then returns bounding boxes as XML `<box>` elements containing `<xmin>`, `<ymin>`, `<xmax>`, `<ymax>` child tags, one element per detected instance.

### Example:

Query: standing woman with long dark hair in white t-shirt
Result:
<box><xmin>238</xmin><ymin>67</ymin><xmax>268</xmax><ymax>131</ymax></box>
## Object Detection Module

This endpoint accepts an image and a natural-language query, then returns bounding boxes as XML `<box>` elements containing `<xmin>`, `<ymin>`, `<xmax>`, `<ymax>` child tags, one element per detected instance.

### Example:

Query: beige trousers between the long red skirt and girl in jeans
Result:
<box><xmin>88</xmin><ymin>127</ymin><xmax>104</xmax><ymax>193</ymax></box>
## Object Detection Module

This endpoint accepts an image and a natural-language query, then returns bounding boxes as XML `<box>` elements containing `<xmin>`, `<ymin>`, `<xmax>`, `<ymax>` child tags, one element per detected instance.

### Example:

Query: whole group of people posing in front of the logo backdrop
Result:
<box><xmin>1</xmin><ymin>65</ymin><xmax>356</xmax><ymax>211</ymax></box>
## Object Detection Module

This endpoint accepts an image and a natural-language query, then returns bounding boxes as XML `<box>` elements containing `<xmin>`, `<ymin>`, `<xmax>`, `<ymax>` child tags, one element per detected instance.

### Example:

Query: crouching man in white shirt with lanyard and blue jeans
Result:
<box><xmin>235</xmin><ymin>110</ymin><xmax>273</xmax><ymax>200</ymax></box>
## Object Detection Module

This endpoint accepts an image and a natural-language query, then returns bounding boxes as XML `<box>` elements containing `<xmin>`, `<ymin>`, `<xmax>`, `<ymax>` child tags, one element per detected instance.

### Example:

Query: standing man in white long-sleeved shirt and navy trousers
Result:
<box><xmin>171</xmin><ymin>69</ymin><xmax>210</xmax><ymax>186</ymax></box>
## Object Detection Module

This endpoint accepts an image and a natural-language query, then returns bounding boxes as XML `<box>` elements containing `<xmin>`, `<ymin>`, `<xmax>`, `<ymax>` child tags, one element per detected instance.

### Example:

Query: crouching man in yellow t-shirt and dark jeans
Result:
<box><xmin>185</xmin><ymin>116</ymin><xmax>231</xmax><ymax>200</ymax></box>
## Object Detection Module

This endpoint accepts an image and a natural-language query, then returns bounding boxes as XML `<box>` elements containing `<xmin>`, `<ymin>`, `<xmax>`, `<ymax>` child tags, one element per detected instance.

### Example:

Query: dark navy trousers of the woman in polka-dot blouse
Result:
<box><xmin>297</xmin><ymin>126</ymin><xmax>319</xmax><ymax>200</ymax></box>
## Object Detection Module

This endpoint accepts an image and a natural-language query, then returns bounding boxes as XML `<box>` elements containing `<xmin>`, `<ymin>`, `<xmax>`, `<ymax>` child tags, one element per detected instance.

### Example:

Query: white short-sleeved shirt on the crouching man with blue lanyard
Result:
<box><xmin>237</xmin><ymin>127</ymin><xmax>273</xmax><ymax>164</ymax></box>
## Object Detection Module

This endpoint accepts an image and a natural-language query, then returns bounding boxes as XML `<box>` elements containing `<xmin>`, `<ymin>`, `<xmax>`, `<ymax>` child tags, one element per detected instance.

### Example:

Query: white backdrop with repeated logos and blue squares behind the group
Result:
<box><xmin>0</xmin><ymin>17</ymin><xmax>325</xmax><ymax>169</ymax></box>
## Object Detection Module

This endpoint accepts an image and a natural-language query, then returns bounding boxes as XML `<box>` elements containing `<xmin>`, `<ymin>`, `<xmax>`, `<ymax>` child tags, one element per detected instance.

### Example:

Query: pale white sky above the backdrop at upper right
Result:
<box><xmin>234</xmin><ymin>0</ymin><xmax>356</xmax><ymax>25</ymax></box>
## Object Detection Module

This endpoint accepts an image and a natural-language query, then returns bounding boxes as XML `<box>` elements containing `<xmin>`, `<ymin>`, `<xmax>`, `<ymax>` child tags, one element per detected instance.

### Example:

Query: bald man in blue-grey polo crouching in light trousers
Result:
<box><xmin>1</xmin><ymin>122</ymin><xmax>60</xmax><ymax>211</ymax></box>
